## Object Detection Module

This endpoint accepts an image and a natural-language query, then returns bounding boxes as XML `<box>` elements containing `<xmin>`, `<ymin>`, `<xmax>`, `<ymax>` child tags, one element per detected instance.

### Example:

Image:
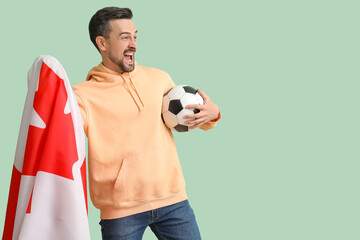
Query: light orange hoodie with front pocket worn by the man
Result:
<box><xmin>73</xmin><ymin>64</ymin><xmax>216</xmax><ymax>219</ymax></box>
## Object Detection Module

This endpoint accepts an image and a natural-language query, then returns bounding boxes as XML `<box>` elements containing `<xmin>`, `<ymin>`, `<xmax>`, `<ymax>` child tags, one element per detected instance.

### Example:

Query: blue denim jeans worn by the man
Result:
<box><xmin>100</xmin><ymin>200</ymin><xmax>201</xmax><ymax>240</ymax></box>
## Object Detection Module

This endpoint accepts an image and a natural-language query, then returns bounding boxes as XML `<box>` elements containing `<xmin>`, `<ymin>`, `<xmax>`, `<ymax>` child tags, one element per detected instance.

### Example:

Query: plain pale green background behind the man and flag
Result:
<box><xmin>0</xmin><ymin>0</ymin><xmax>360</xmax><ymax>240</ymax></box>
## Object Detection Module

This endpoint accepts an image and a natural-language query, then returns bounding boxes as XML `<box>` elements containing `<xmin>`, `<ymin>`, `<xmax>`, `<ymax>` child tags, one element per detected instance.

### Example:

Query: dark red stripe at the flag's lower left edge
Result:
<box><xmin>2</xmin><ymin>165</ymin><xmax>21</xmax><ymax>240</ymax></box>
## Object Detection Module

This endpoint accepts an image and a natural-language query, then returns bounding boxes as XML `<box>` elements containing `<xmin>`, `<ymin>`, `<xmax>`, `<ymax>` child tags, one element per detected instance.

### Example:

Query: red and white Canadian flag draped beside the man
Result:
<box><xmin>2</xmin><ymin>56</ymin><xmax>90</xmax><ymax>240</ymax></box>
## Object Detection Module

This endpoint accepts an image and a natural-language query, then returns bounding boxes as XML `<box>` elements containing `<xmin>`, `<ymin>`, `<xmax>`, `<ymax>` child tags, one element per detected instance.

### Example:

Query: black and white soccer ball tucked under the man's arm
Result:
<box><xmin>161</xmin><ymin>85</ymin><xmax>204</xmax><ymax>132</ymax></box>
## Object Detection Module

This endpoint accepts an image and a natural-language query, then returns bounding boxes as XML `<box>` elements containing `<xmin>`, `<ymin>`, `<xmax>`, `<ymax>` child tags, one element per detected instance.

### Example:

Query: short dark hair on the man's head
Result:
<box><xmin>89</xmin><ymin>7</ymin><xmax>133</xmax><ymax>52</ymax></box>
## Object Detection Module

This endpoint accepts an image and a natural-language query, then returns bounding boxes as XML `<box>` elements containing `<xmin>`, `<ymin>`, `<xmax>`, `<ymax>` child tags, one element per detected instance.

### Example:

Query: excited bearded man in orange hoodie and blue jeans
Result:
<box><xmin>74</xmin><ymin>7</ymin><xmax>220</xmax><ymax>240</ymax></box>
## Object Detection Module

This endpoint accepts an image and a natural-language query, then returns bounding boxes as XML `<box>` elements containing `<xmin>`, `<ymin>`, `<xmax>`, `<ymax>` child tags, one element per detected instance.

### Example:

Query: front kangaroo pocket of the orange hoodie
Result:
<box><xmin>113</xmin><ymin>150</ymin><xmax>185</xmax><ymax>207</ymax></box>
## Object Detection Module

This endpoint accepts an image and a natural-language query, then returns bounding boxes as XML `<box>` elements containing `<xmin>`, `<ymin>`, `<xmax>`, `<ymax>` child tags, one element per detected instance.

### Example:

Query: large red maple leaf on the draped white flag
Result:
<box><xmin>22</xmin><ymin>63</ymin><xmax>78</xmax><ymax>212</ymax></box>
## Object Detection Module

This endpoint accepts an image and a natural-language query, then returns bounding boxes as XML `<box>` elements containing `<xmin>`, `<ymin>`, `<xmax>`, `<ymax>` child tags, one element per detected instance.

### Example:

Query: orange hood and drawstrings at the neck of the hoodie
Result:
<box><xmin>86</xmin><ymin>62</ymin><xmax>145</xmax><ymax>112</ymax></box>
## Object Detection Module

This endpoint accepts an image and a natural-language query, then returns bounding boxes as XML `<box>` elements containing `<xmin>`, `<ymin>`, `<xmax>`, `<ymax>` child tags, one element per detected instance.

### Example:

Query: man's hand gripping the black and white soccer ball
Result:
<box><xmin>184</xmin><ymin>90</ymin><xmax>220</xmax><ymax>129</ymax></box>
